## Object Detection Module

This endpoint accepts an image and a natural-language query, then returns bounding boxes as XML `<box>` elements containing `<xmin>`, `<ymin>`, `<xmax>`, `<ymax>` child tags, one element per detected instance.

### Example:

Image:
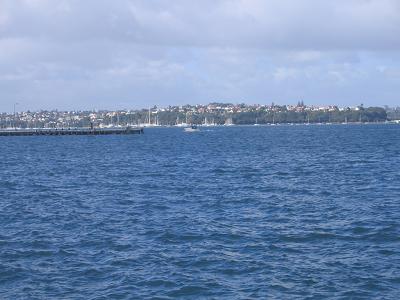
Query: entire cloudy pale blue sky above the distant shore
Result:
<box><xmin>0</xmin><ymin>0</ymin><xmax>400</xmax><ymax>112</ymax></box>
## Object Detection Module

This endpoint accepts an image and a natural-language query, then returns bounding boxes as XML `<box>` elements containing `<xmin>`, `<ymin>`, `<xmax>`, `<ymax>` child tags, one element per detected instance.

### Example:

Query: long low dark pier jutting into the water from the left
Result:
<box><xmin>0</xmin><ymin>127</ymin><xmax>144</xmax><ymax>136</ymax></box>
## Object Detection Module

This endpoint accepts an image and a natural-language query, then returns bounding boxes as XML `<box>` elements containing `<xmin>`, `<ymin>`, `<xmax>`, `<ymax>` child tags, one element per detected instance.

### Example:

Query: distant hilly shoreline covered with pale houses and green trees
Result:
<box><xmin>0</xmin><ymin>102</ymin><xmax>400</xmax><ymax>128</ymax></box>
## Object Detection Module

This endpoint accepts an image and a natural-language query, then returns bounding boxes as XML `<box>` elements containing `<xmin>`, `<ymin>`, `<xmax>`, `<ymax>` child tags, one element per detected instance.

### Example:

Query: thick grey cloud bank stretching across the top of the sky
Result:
<box><xmin>0</xmin><ymin>0</ymin><xmax>400</xmax><ymax>50</ymax></box>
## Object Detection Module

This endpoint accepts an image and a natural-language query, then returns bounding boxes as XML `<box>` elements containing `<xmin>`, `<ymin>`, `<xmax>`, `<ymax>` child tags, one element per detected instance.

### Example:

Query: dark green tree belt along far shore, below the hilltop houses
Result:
<box><xmin>0</xmin><ymin>107</ymin><xmax>388</xmax><ymax>128</ymax></box>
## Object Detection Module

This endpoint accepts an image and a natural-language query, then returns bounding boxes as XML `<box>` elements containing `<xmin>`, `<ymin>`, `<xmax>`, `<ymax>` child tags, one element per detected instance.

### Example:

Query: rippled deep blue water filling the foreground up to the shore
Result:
<box><xmin>0</xmin><ymin>125</ymin><xmax>400</xmax><ymax>299</ymax></box>
